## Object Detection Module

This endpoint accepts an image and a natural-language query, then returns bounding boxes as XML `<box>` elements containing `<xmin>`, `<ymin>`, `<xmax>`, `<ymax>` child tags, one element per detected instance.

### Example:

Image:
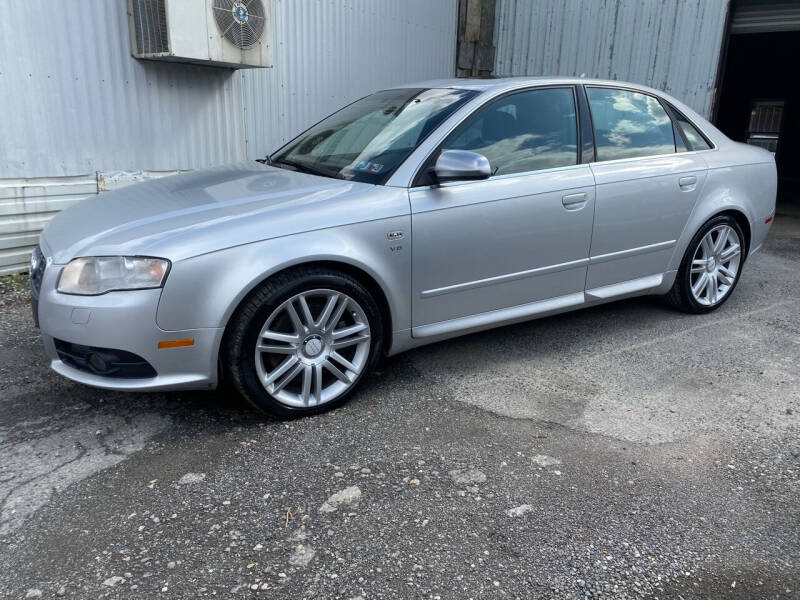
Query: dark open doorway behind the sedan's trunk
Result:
<box><xmin>716</xmin><ymin>31</ymin><xmax>800</xmax><ymax>212</ymax></box>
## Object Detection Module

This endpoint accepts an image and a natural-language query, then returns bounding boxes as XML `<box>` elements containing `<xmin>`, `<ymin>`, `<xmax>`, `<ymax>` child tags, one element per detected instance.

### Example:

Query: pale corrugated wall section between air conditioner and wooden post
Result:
<box><xmin>242</xmin><ymin>0</ymin><xmax>458</xmax><ymax>158</ymax></box>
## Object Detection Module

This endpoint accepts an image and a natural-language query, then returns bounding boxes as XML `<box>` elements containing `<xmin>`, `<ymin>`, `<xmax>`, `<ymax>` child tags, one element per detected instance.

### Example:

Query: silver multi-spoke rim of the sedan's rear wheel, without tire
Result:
<box><xmin>689</xmin><ymin>225</ymin><xmax>742</xmax><ymax>306</ymax></box>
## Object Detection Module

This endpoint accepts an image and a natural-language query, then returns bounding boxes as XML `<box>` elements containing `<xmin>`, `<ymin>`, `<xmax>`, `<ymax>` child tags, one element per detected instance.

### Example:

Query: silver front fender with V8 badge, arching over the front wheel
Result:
<box><xmin>156</xmin><ymin>215</ymin><xmax>411</xmax><ymax>331</ymax></box>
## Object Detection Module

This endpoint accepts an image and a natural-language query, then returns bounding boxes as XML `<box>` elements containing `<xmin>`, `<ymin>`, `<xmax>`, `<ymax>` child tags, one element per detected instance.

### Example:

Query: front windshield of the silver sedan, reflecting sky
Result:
<box><xmin>270</xmin><ymin>88</ymin><xmax>475</xmax><ymax>184</ymax></box>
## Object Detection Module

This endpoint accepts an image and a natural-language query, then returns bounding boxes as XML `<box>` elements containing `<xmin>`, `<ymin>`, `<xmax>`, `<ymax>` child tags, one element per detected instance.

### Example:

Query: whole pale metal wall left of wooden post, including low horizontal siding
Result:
<box><xmin>0</xmin><ymin>0</ymin><xmax>457</xmax><ymax>274</ymax></box>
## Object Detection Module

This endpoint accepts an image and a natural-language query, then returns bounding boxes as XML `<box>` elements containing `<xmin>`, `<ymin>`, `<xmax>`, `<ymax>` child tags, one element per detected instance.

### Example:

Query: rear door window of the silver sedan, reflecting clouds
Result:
<box><xmin>586</xmin><ymin>87</ymin><xmax>676</xmax><ymax>161</ymax></box>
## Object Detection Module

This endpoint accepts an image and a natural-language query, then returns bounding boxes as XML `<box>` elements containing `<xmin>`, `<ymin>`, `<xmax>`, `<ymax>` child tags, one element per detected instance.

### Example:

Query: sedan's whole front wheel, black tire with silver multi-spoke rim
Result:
<box><xmin>222</xmin><ymin>267</ymin><xmax>383</xmax><ymax>419</ymax></box>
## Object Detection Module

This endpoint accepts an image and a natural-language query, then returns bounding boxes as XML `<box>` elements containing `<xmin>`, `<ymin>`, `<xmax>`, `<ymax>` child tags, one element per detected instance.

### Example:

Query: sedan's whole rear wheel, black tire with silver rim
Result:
<box><xmin>665</xmin><ymin>215</ymin><xmax>747</xmax><ymax>314</ymax></box>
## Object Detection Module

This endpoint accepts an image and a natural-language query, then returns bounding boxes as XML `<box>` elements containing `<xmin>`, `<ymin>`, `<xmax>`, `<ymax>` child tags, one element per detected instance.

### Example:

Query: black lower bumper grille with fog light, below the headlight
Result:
<box><xmin>53</xmin><ymin>340</ymin><xmax>157</xmax><ymax>379</ymax></box>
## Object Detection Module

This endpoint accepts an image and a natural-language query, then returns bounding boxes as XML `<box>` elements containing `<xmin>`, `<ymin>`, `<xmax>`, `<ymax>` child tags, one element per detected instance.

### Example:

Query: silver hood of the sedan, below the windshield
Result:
<box><xmin>42</xmin><ymin>161</ymin><xmax>397</xmax><ymax>264</ymax></box>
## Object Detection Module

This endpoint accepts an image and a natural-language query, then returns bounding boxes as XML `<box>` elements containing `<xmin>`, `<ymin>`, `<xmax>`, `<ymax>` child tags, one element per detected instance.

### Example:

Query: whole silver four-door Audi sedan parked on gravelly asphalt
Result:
<box><xmin>31</xmin><ymin>78</ymin><xmax>776</xmax><ymax>417</ymax></box>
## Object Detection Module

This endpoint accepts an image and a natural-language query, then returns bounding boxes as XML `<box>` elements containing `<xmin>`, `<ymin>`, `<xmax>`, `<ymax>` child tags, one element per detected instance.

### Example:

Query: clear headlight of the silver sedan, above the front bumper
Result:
<box><xmin>57</xmin><ymin>256</ymin><xmax>170</xmax><ymax>296</ymax></box>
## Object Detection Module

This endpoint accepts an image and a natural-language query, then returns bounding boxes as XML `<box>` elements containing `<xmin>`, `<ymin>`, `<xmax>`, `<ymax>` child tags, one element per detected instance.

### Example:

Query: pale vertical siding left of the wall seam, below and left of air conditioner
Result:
<box><xmin>0</xmin><ymin>0</ymin><xmax>244</xmax><ymax>177</ymax></box>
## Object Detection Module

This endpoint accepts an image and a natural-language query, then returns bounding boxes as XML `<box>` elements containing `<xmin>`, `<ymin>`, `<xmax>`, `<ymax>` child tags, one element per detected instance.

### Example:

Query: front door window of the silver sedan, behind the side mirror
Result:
<box><xmin>442</xmin><ymin>88</ymin><xmax>578</xmax><ymax>175</ymax></box>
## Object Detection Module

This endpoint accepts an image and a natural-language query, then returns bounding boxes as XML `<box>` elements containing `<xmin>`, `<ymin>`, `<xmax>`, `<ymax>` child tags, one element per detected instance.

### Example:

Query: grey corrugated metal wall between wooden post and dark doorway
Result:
<box><xmin>495</xmin><ymin>0</ymin><xmax>728</xmax><ymax>116</ymax></box>
